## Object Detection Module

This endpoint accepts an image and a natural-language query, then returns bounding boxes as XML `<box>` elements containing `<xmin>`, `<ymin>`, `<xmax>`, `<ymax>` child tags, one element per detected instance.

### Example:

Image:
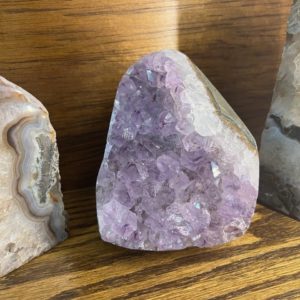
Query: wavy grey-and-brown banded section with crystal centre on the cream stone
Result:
<box><xmin>7</xmin><ymin>113</ymin><xmax>66</xmax><ymax>241</ymax></box>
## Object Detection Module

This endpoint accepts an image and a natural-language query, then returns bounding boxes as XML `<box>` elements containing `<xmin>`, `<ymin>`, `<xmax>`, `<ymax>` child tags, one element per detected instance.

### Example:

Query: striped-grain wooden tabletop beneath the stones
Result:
<box><xmin>0</xmin><ymin>189</ymin><xmax>300</xmax><ymax>300</ymax></box>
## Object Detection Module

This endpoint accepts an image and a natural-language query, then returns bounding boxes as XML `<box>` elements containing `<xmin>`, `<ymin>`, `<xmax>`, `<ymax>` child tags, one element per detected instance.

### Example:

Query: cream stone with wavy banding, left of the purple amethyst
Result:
<box><xmin>0</xmin><ymin>77</ymin><xmax>67</xmax><ymax>276</ymax></box>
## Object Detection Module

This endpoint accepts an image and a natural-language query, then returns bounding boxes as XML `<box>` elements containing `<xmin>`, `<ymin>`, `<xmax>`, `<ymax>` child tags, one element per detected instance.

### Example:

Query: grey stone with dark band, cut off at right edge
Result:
<box><xmin>259</xmin><ymin>0</ymin><xmax>300</xmax><ymax>220</ymax></box>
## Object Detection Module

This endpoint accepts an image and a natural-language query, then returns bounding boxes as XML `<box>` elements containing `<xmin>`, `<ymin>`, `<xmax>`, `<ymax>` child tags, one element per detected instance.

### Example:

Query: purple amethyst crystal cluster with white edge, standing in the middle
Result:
<box><xmin>97</xmin><ymin>50</ymin><xmax>258</xmax><ymax>250</ymax></box>
